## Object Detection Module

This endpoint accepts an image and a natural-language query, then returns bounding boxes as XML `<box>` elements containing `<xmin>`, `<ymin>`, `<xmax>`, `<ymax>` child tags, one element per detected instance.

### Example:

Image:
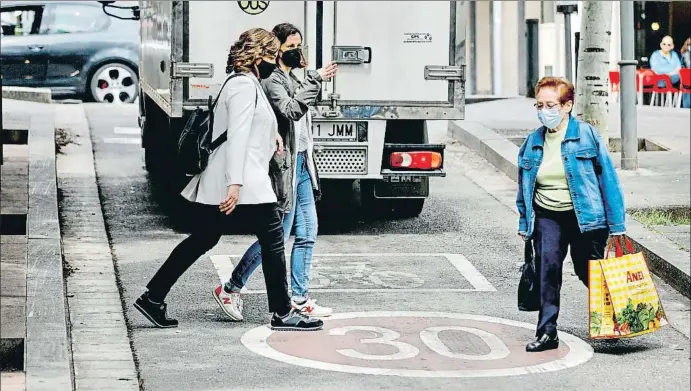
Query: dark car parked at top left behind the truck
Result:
<box><xmin>0</xmin><ymin>1</ymin><xmax>139</xmax><ymax>103</ymax></box>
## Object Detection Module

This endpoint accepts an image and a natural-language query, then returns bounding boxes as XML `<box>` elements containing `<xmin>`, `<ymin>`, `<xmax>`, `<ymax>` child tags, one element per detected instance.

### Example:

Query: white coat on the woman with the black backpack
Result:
<box><xmin>181</xmin><ymin>73</ymin><xmax>278</xmax><ymax>205</ymax></box>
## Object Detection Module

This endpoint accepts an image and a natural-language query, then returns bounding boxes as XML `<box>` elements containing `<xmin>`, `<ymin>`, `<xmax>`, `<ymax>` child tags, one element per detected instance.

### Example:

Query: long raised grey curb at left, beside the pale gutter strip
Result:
<box><xmin>25</xmin><ymin>105</ymin><xmax>72</xmax><ymax>391</ymax></box>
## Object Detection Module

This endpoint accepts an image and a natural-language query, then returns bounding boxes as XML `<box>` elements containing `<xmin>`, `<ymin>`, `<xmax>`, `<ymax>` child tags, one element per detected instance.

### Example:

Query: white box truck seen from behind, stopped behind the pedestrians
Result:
<box><xmin>102</xmin><ymin>1</ymin><xmax>467</xmax><ymax>217</ymax></box>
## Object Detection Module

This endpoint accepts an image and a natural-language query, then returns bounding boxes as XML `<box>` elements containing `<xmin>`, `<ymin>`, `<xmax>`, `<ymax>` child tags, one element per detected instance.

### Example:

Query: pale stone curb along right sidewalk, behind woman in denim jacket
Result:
<box><xmin>448</xmin><ymin>121</ymin><xmax>691</xmax><ymax>298</ymax></box>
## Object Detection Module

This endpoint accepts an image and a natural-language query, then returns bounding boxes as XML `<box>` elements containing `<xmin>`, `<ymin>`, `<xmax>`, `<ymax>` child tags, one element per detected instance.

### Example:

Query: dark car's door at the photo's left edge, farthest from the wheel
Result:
<box><xmin>0</xmin><ymin>5</ymin><xmax>48</xmax><ymax>87</ymax></box>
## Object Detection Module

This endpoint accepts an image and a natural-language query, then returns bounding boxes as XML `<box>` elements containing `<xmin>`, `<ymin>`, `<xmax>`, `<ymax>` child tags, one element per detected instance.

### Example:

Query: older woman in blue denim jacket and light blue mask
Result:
<box><xmin>516</xmin><ymin>77</ymin><xmax>626</xmax><ymax>352</ymax></box>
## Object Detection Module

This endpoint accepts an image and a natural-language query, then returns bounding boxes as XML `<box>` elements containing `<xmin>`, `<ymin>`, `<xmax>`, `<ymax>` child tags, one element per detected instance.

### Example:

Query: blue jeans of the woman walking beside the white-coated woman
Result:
<box><xmin>229</xmin><ymin>152</ymin><xmax>317</xmax><ymax>301</ymax></box>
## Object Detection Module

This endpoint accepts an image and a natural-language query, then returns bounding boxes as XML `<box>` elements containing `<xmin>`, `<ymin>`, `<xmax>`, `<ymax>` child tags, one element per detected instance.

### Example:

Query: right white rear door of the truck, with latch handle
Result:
<box><xmin>317</xmin><ymin>1</ymin><xmax>456</xmax><ymax>106</ymax></box>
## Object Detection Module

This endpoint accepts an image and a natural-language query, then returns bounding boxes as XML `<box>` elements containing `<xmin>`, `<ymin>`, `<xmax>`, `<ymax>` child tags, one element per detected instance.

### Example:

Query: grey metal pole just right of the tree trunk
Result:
<box><xmin>619</xmin><ymin>1</ymin><xmax>638</xmax><ymax>170</ymax></box>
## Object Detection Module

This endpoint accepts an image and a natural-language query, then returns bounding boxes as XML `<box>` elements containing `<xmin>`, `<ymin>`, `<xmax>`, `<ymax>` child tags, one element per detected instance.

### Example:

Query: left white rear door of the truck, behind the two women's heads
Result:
<box><xmin>187</xmin><ymin>1</ymin><xmax>308</xmax><ymax>101</ymax></box>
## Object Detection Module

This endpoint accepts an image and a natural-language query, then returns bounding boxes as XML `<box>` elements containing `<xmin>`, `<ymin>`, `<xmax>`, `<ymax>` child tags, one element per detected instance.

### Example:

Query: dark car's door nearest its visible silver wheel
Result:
<box><xmin>44</xmin><ymin>2</ymin><xmax>112</xmax><ymax>88</ymax></box>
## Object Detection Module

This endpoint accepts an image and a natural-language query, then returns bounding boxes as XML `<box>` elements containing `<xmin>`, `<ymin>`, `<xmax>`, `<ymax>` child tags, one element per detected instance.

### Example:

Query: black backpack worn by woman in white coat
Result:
<box><xmin>177</xmin><ymin>73</ymin><xmax>259</xmax><ymax>176</ymax></box>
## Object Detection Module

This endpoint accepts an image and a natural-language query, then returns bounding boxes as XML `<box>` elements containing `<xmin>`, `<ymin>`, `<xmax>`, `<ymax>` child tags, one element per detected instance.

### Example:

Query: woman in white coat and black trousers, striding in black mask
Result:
<box><xmin>134</xmin><ymin>28</ymin><xmax>323</xmax><ymax>330</ymax></box>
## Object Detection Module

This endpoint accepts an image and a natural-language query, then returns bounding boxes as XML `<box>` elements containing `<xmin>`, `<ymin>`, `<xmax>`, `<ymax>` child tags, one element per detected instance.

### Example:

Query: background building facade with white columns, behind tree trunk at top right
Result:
<box><xmin>466</xmin><ymin>0</ymin><xmax>691</xmax><ymax>96</ymax></box>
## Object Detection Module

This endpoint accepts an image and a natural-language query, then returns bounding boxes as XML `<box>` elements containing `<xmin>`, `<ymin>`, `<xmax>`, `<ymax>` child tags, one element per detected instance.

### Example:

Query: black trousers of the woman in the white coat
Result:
<box><xmin>147</xmin><ymin>203</ymin><xmax>290</xmax><ymax>315</ymax></box>
